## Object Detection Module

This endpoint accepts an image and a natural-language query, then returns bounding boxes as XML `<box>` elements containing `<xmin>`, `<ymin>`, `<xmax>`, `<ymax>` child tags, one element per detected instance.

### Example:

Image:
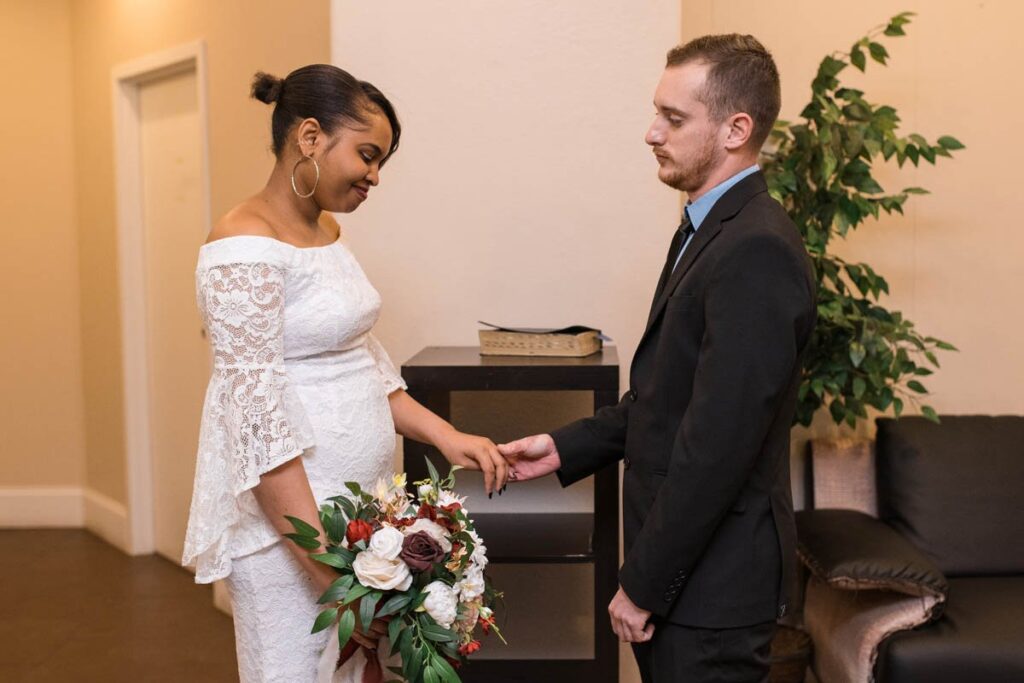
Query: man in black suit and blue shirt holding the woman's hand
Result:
<box><xmin>500</xmin><ymin>35</ymin><xmax>815</xmax><ymax>683</ymax></box>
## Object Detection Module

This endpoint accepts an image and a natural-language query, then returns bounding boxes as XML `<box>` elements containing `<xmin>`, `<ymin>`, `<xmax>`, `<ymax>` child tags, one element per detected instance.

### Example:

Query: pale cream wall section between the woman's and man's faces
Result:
<box><xmin>334</xmin><ymin>0</ymin><xmax>679</xmax><ymax>403</ymax></box>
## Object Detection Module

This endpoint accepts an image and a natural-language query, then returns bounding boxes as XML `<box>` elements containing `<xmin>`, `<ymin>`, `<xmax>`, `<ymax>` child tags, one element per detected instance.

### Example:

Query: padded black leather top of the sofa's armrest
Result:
<box><xmin>797</xmin><ymin>510</ymin><xmax>949</xmax><ymax>604</ymax></box>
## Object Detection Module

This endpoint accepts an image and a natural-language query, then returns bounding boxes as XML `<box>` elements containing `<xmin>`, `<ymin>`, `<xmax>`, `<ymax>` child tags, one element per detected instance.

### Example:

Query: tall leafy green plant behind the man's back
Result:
<box><xmin>762</xmin><ymin>12</ymin><xmax>964</xmax><ymax>427</ymax></box>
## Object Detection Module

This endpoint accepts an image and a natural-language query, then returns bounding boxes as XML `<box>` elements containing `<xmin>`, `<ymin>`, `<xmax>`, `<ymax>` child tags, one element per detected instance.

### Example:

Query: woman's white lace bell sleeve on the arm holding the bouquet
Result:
<box><xmin>182</xmin><ymin>262</ymin><xmax>313</xmax><ymax>583</ymax></box>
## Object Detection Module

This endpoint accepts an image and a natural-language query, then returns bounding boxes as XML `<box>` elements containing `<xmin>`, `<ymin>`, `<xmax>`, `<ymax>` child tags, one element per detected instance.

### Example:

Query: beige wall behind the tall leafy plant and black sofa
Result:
<box><xmin>682</xmin><ymin>0</ymin><xmax>1024</xmax><ymax>504</ymax></box>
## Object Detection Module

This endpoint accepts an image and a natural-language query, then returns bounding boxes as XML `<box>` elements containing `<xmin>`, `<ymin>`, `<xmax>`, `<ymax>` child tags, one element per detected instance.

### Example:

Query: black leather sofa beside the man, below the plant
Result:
<box><xmin>797</xmin><ymin>416</ymin><xmax>1024</xmax><ymax>683</ymax></box>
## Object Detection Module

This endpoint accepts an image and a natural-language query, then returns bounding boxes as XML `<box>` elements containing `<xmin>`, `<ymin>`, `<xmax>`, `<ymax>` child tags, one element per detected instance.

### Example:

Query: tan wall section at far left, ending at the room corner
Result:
<box><xmin>0</xmin><ymin>0</ymin><xmax>85</xmax><ymax>491</ymax></box>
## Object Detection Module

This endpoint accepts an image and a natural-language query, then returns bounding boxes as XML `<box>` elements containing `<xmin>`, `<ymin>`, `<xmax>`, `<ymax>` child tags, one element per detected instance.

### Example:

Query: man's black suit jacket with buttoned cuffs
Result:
<box><xmin>552</xmin><ymin>172</ymin><xmax>816</xmax><ymax>628</ymax></box>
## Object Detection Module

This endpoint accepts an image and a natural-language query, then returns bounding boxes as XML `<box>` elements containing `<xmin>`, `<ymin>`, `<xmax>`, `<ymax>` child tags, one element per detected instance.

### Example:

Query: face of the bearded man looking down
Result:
<box><xmin>644</xmin><ymin>62</ymin><xmax>726</xmax><ymax>193</ymax></box>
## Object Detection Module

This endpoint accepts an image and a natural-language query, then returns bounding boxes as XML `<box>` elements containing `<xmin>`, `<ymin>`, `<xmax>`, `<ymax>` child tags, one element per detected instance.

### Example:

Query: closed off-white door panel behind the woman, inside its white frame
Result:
<box><xmin>138</xmin><ymin>67</ymin><xmax>210</xmax><ymax>563</ymax></box>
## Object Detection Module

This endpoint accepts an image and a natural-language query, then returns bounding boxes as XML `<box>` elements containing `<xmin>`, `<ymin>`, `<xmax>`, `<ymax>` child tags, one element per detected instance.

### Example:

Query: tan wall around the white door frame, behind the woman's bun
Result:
<box><xmin>73</xmin><ymin>0</ymin><xmax>330</xmax><ymax>502</ymax></box>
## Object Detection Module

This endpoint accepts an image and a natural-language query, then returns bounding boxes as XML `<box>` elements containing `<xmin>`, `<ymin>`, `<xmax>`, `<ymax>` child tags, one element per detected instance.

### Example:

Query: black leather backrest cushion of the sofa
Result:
<box><xmin>877</xmin><ymin>416</ymin><xmax>1024</xmax><ymax>577</ymax></box>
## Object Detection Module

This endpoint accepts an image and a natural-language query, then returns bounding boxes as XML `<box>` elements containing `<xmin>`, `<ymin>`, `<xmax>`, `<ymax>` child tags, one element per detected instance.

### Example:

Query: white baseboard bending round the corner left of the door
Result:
<box><xmin>0</xmin><ymin>486</ymin><xmax>128</xmax><ymax>552</ymax></box>
